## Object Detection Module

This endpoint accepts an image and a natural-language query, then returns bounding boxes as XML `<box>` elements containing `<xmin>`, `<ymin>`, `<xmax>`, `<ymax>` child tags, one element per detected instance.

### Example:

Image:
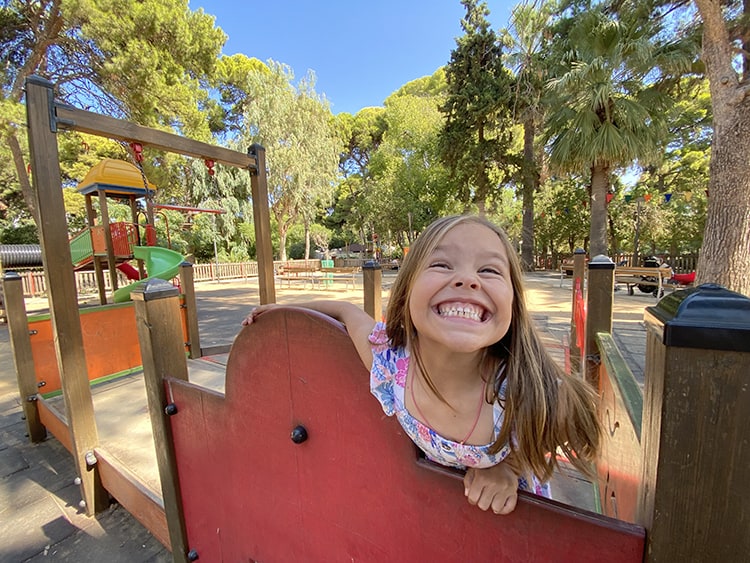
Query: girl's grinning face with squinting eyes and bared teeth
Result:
<box><xmin>409</xmin><ymin>223</ymin><xmax>513</xmax><ymax>353</ymax></box>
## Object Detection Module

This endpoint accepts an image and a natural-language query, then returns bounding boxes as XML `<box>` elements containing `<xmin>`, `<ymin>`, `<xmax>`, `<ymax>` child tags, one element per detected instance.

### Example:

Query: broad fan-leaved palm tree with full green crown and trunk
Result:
<box><xmin>547</xmin><ymin>7</ymin><xmax>680</xmax><ymax>256</ymax></box>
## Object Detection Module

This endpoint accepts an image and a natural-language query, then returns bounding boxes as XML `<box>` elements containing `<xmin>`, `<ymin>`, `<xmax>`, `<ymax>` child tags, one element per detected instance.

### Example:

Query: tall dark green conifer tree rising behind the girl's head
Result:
<box><xmin>440</xmin><ymin>0</ymin><xmax>513</xmax><ymax>212</ymax></box>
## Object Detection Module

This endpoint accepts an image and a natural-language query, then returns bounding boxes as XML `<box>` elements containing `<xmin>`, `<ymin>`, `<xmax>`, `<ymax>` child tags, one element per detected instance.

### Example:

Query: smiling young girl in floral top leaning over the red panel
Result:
<box><xmin>243</xmin><ymin>215</ymin><xmax>601</xmax><ymax>514</ymax></box>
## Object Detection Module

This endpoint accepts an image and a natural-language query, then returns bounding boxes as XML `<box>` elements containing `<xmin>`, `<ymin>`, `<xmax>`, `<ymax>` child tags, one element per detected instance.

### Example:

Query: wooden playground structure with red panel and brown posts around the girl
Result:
<box><xmin>3</xmin><ymin>78</ymin><xmax>750</xmax><ymax>562</ymax></box>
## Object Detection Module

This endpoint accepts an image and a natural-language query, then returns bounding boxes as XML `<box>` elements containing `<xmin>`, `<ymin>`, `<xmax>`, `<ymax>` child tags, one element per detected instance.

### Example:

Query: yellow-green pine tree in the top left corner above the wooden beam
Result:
<box><xmin>0</xmin><ymin>0</ymin><xmax>226</xmax><ymax>227</ymax></box>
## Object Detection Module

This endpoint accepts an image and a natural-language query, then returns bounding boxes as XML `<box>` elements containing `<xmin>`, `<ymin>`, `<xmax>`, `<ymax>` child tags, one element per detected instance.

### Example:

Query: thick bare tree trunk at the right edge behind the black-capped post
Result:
<box><xmin>696</xmin><ymin>0</ymin><xmax>750</xmax><ymax>295</ymax></box>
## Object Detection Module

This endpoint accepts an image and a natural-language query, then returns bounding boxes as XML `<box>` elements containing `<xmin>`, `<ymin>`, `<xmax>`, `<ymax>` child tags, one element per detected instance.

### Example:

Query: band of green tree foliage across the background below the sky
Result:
<box><xmin>0</xmin><ymin>0</ymin><xmax>716</xmax><ymax>270</ymax></box>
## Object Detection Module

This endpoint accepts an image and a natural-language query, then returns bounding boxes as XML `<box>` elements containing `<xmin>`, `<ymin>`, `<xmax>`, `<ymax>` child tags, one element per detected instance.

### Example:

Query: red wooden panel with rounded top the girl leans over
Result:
<box><xmin>166</xmin><ymin>309</ymin><xmax>644</xmax><ymax>563</ymax></box>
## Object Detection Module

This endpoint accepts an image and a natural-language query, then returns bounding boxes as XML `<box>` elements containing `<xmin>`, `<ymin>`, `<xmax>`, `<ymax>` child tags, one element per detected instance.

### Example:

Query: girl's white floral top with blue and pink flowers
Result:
<box><xmin>369</xmin><ymin>323</ymin><xmax>550</xmax><ymax>497</ymax></box>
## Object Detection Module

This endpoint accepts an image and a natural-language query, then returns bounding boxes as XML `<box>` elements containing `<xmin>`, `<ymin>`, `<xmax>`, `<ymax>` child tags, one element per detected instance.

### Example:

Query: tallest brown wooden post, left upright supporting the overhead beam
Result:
<box><xmin>26</xmin><ymin>76</ymin><xmax>109</xmax><ymax>514</ymax></box>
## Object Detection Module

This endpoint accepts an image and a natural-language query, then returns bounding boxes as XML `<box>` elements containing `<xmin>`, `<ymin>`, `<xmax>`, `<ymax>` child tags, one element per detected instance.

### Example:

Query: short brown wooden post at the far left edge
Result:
<box><xmin>3</xmin><ymin>272</ymin><xmax>47</xmax><ymax>442</ymax></box>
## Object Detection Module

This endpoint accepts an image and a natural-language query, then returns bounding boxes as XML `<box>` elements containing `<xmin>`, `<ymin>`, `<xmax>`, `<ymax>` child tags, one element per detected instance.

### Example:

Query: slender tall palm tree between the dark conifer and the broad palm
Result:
<box><xmin>503</xmin><ymin>0</ymin><xmax>554</xmax><ymax>270</ymax></box>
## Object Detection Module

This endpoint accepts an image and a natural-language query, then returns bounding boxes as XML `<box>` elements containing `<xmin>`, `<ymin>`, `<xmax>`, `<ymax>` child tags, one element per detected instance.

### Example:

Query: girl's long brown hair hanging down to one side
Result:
<box><xmin>386</xmin><ymin>215</ymin><xmax>601</xmax><ymax>481</ymax></box>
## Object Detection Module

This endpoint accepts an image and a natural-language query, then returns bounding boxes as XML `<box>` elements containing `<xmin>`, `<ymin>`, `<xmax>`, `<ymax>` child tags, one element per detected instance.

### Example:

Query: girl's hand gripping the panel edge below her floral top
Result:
<box><xmin>464</xmin><ymin>461</ymin><xmax>518</xmax><ymax>514</ymax></box>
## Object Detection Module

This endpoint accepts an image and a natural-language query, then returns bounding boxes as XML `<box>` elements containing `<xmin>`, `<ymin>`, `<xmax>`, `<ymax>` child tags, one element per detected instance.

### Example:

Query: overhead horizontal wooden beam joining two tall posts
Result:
<box><xmin>53</xmin><ymin>103</ymin><xmax>258</xmax><ymax>170</ymax></box>
